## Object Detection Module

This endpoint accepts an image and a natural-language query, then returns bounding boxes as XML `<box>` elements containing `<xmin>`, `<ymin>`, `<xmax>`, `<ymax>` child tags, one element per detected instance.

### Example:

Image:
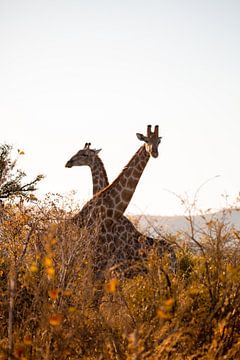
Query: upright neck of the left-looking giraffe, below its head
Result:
<box><xmin>90</xmin><ymin>156</ymin><xmax>109</xmax><ymax>195</ymax></box>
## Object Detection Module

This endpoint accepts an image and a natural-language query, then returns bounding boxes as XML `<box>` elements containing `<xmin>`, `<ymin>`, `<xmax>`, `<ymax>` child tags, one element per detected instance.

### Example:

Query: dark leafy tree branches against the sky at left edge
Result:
<box><xmin>0</xmin><ymin>144</ymin><xmax>43</xmax><ymax>199</ymax></box>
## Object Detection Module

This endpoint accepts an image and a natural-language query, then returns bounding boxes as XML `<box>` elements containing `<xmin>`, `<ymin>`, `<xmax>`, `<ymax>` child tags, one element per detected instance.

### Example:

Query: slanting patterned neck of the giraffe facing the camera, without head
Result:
<box><xmin>99</xmin><ymin>145</ymin><xmax>150</xmax><ymax>219</ymax></box>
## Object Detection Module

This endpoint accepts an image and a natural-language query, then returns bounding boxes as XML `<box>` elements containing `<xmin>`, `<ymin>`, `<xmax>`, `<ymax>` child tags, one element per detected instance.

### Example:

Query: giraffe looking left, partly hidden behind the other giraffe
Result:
<box><xmin>66</xmin><ymin>143</ymin><xmax>176</xmax><ymax>272</ymax></box>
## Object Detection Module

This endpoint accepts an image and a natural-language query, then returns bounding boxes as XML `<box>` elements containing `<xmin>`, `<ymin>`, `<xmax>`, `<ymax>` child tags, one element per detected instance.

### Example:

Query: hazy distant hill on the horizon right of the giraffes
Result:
<box><xmin>131</xmin><ymin>209</ymin><xmax>240</xmax><ymax>236</ymax></box>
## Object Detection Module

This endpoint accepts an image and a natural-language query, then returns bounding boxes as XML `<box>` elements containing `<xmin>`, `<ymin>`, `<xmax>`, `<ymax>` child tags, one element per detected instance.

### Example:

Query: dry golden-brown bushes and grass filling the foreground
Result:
<box><xmin>0</xmin><ymin>195</ymin><xmax>240</xmax><ymax>360</ymax></box>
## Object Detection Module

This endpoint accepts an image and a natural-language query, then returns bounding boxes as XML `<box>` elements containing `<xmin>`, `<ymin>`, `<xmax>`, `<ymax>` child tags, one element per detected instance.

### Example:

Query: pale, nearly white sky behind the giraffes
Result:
<box><xmin>0</xmin><ymin>0</ymin><xmax>240</xmax><ymax>215</ymax></box>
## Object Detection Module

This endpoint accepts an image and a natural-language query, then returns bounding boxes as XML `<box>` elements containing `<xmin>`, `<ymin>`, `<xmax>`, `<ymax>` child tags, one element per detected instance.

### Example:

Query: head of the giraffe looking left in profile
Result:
<box><xmin>65</xmin><ymin>143</ymin><xmax>101</xmax><ymax>168</ymax></box>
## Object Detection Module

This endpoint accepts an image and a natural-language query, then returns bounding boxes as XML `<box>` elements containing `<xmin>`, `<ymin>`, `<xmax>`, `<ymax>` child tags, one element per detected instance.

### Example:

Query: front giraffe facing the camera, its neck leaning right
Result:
<box><xmin>65</xmin><ymin>125</ymin><xmax>175</xmax><ymax>278</ymax></box>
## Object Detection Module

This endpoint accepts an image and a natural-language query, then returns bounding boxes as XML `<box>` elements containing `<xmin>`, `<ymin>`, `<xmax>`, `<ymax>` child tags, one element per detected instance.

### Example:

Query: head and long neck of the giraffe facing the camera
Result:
<box><xmin>71</xmin><ymin>125</ymin><xmax>161</xmax><ymax>228</ymax></box>
